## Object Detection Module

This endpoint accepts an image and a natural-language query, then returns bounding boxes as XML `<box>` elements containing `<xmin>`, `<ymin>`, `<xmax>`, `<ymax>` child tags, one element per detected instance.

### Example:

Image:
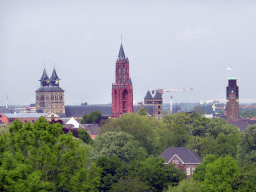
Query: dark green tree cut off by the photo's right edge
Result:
<box><xmin>237</xmin><ymin>125</ymin><xmax>256</xmax><ymax>166</ymax></box>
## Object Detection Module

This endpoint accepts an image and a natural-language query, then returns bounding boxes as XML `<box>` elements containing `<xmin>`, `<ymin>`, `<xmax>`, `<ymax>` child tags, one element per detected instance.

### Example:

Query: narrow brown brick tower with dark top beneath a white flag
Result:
<box><xmin>227</xmin><ymin>77</ymin><xmax>239</xmax><ymax>122</ymax></box>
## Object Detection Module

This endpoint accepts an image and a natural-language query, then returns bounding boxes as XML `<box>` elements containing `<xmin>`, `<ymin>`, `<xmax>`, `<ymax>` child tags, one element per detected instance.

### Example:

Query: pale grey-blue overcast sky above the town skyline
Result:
<box><xmin>0</xmin><ymin>0</ymin><xmax>256</xmax><ymax>105</ymax></box>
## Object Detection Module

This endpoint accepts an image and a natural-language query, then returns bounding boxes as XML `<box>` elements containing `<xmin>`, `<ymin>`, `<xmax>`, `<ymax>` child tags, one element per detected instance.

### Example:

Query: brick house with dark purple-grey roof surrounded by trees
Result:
<box><xmin>160</xmin><ymin>147</ymin><xmax>202</xmax><ymax>177</ymax></box>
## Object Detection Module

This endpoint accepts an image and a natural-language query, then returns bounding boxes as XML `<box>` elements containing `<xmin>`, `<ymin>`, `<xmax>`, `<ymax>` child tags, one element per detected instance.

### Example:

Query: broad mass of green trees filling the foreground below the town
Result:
<box><xmin>0</xmin><ymin>110</ymin><xmax>256</xmax><ymax>191</ymax></box>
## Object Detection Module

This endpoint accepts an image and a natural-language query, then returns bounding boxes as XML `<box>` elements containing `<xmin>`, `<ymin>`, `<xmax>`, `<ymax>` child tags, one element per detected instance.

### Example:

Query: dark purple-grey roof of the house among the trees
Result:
<box><xmin>160</xmin><ymin>147</ymin><xmax>202</xmax><ymax>164</ymax></box>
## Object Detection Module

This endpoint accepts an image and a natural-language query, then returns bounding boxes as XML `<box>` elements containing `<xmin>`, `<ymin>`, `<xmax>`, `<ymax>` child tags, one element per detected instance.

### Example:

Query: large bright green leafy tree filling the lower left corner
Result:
<box><xmin>0</xmin><ymin>117</ymin><xmax>100</xmax><ymax>191</ymax></box>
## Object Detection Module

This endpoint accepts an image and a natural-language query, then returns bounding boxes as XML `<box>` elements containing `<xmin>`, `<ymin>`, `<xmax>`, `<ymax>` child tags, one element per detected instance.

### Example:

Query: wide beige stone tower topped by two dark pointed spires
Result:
<box><xmin>36</xmin><ymin>68</ymin><xmax>65</xmax><ymax>114</ymax></box>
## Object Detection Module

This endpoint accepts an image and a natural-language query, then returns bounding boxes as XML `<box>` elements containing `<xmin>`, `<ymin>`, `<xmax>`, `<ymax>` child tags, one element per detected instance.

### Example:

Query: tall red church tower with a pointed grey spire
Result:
<box><xmin>111</xmin><ymin>44</ymin><xmax>133</xmax><ymax>118</ymax></box>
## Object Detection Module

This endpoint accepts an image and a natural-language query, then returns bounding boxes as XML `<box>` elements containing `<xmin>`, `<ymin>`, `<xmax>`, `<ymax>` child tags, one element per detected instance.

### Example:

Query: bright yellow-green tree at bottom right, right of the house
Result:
<box><xmin>204</xmin><ymin>156</ymin><xmax>239</xmax><ymax>191</ymax></box>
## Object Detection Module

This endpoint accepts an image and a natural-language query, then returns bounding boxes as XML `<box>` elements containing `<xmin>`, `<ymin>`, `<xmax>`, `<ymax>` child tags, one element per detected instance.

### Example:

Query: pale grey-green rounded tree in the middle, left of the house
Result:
<box><xmin>91</xmin><ymin>132</ymin><xmax>146</xmax><ymax>162</ymax></box>
